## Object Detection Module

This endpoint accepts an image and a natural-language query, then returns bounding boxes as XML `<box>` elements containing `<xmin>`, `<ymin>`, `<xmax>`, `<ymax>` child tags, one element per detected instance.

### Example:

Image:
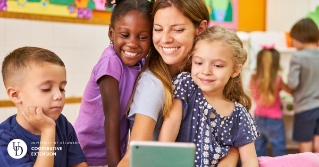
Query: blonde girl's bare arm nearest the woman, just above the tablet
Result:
<box><xmin>158</xmin><ymin>99</ymin><xmax>183</xmax><ymax>142</ymax></box>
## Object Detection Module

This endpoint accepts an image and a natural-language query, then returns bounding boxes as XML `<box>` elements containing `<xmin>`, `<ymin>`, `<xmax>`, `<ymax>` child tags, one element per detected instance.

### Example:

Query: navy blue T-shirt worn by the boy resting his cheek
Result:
<box><xmin>0</xmin><ymin>114</ymin><xmax>86</xmax><ymax>167</ymax></box>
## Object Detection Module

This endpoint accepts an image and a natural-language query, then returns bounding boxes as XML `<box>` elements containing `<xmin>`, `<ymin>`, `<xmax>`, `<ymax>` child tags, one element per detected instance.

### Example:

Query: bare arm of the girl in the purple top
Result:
<box><xmin>99</xmin><ymin>75</ymin><xmax>121</xmax><ymax>167</ymax></box>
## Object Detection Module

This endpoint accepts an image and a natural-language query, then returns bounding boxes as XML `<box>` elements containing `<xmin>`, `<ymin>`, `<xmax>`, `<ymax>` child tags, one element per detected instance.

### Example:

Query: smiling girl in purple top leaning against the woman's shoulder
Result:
<box><xmin>74</xmin><ymin>0</ymin><xmax>153</xmax><ymax>167</ymax></box>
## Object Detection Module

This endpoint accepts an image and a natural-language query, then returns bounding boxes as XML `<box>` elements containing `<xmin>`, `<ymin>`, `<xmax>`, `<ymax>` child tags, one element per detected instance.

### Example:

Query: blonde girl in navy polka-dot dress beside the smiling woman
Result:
<box><xmin>159</xmin><ymin>26</ymin><xmax>259</xmax><ymax>167</ymax></box>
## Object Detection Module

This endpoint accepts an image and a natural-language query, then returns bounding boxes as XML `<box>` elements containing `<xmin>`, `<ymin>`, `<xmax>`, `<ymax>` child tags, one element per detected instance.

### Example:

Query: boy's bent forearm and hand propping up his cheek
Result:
<box><xmin>22</xmin><ymin>107</ymin><xmax>56</xmax><ymax>167</ymax></box>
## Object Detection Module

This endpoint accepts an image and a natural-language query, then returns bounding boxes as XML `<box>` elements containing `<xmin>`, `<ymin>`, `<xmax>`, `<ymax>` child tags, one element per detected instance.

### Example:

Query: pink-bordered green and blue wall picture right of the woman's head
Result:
<box><xmin>205</xmin><ymin>0</ymin><xmax>238</xmax><ymax>30</ymax></box>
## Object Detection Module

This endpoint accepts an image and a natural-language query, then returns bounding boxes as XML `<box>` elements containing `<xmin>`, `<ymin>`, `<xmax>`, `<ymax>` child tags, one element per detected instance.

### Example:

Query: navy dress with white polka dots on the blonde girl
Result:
<box><xmin>173</xmin><ymin>72</ymin><xmax>259</xmax><ymax>167</ymax></box>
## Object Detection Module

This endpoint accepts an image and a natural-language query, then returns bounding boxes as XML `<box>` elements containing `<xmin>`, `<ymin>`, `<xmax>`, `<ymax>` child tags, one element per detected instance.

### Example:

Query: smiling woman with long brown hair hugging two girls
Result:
<box><xmin>119</xmin><ymin>0</ymin><xmax>209</xmax><ymax>166</ymax></box>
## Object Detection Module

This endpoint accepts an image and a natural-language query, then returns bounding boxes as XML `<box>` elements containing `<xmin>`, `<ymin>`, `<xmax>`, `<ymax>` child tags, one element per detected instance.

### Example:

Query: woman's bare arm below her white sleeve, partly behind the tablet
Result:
<box><xmin>118</xmin><ymin>114</ymin><xmax>156</xmax><ymax>167</ymax></box>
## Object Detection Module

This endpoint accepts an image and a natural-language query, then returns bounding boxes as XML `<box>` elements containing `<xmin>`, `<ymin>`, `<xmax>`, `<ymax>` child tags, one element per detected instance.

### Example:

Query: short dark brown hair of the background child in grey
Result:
<box><xmin>290</xmin><ymin>19</ymin><xmax>319</xmax><ymax>43</ymax></box>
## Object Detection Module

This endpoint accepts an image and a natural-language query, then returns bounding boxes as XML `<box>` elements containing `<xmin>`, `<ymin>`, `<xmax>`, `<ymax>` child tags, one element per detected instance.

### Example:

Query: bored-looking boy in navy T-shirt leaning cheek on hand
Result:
<box><xmin>0</xmin><ymin>47</ymin><xmax>88</xmax><ymax>167</ymax></box>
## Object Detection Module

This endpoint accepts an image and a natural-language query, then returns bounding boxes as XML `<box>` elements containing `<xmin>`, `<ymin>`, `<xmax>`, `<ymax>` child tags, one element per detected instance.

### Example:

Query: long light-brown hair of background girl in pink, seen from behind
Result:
<box><xmin>252</xmin><ymin>49</ymin><xmax>280</xmax><ymax>106</ymax></box>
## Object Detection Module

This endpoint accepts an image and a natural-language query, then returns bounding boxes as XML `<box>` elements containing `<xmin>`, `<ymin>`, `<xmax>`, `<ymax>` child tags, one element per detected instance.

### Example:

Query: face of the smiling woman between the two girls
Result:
<box><xmin>153</xmin><ymin>7</ymin><xmax>197</xmax><ymax>69</ymax></box>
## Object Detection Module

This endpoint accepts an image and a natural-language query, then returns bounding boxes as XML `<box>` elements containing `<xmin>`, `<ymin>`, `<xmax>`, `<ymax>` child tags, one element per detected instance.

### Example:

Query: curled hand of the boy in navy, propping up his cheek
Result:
<box><xmin>22</xmin><ymin>107</ymin><xmax>56</xmax><ymax>132</ymax></box>
